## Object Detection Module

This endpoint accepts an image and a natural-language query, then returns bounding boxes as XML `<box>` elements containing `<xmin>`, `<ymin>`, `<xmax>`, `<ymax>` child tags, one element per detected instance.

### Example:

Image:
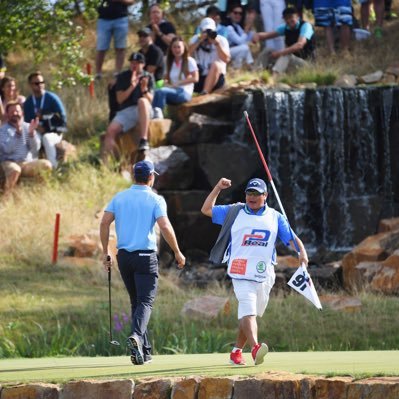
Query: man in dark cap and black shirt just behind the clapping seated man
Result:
<box><xmin>137</xmin><ymin>28</ymin><xmax>165</xmax><ymax>87</ymax></box>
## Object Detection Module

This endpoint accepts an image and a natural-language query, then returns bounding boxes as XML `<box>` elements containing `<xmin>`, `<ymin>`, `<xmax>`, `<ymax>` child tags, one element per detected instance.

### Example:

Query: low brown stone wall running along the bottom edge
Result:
<box><xmin>0</xmin><ymin>372</ymin><xmax>399</xmax><ymax>399</ymax></box>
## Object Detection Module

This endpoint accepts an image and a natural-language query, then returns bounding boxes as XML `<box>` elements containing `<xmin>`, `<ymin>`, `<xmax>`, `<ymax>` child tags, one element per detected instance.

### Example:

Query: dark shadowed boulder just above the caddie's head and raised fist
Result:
<box><xmin>197</xmin><ymin>143</ymin><xmax>259</xmax><ymax>189</ymax></box>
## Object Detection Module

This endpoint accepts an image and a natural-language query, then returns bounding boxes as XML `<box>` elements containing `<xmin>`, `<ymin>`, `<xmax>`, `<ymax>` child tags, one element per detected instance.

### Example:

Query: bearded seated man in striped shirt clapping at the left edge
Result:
<box><xmin>0</xmin><ymin>102</ymin><xmax>52</xmax><ymax>196</ymax></box>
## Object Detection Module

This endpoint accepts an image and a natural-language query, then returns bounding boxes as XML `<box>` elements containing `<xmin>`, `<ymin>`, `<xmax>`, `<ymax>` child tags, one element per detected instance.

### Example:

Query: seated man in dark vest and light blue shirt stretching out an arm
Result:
<box><xmin>254</xmin><ymin>7</ymin><xmax>315</xmax><ymax>74</ymax></box>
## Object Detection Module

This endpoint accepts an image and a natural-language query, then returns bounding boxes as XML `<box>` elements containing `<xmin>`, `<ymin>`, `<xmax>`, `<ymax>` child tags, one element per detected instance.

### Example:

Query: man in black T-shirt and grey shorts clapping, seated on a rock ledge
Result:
<box><xmin>102</xmin><ymin>53</ymin><xmax>154</xmax><ymax>161</ymax></box>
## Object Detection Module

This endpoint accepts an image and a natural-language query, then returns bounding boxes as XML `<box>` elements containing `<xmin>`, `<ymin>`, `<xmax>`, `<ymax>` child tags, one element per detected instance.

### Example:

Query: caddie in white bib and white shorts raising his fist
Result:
<box><xmin>201</xmin><ymin>178</ymin><xmax>308</xmax><ymax>365</ymax></box>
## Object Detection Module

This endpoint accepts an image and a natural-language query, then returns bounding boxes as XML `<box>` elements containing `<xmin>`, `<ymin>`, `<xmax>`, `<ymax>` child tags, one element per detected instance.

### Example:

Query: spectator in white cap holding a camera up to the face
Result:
<box><xmin>189</xmin><ymin>17</ymin><xmax>230</xmax><ymax>94</ymax></box>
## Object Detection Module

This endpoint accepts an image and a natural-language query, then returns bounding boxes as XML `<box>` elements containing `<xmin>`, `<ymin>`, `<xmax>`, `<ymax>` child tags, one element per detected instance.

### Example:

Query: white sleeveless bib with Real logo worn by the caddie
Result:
<box><xmin>227</xmin><ymin>207</ymin><xmax>278</xmax><ymax>283</ymax></box>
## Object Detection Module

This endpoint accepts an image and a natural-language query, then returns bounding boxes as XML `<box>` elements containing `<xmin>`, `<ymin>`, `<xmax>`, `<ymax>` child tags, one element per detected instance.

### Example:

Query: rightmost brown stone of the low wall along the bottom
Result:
<box><xmin>346</xmin><ymin>377</ymin><xmax>399</xmax><ymax>399</ymax></box>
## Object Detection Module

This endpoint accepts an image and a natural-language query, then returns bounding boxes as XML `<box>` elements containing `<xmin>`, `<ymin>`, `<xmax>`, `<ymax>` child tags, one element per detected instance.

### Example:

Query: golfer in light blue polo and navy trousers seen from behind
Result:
<box><xmin>100</xmin><ymin>160</ymin><xmax>186</xmax><ymax>365</ymax></box>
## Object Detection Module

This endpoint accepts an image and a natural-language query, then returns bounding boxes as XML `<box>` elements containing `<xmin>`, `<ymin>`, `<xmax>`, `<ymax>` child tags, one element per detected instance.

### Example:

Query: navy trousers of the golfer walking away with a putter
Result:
<box><xmin>117</xmin><ymin>249</ymin><xmax>158</xmax><ymax>356</ymax></box>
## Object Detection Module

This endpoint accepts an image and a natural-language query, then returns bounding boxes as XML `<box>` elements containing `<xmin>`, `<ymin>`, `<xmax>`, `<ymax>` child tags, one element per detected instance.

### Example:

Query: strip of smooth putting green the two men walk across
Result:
<box><xmin>0</xmin><ymin>351</ymin><xmax>399</xmax><ymax>383</ymax></box>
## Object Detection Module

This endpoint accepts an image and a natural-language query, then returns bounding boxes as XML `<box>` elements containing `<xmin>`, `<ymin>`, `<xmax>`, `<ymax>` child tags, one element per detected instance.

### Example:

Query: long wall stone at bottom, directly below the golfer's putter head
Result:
<box><xmin>60</xmin><ymin>379</ymin><xmax>134</xmax><ymax>399</ymax></box>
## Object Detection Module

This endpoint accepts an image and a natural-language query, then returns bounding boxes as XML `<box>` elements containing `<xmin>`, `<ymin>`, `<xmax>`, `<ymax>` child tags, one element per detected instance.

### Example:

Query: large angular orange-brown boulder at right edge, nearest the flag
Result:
<box><xmin>342</xmin><ymin>230</ymin><xmax>399</xmax><ymax>290</ymax></box>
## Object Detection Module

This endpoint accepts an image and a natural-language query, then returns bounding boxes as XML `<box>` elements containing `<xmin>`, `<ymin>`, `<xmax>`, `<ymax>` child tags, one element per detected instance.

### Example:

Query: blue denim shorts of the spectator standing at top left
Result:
<box><xmin>97</xmin><ymin>17</ymin><xmax>129</xmax><ymax>51</ymax></box>
